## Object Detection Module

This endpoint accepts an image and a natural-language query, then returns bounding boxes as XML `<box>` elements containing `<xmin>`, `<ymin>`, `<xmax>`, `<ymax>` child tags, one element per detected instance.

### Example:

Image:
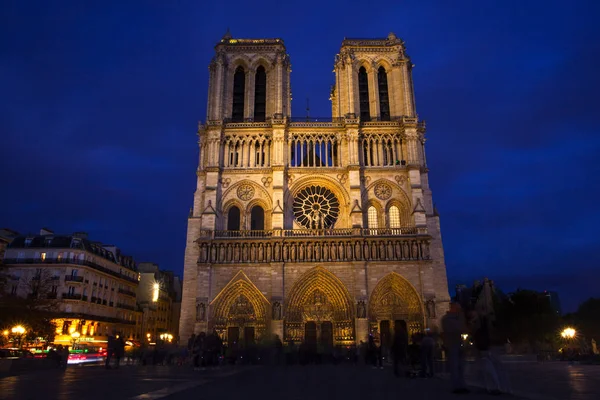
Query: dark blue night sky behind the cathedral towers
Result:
<box><xmin>0</xmin><ymin>0</ymin><xmax>600</xmax><ymax>310</ymax></box>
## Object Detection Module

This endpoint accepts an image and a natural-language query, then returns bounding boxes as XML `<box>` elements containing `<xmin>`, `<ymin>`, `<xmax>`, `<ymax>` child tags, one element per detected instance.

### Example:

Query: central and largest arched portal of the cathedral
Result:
<box><xmin>284</xmin><ymin>267</ymin><xmax>355</xmax><ymax>345</ymax></box>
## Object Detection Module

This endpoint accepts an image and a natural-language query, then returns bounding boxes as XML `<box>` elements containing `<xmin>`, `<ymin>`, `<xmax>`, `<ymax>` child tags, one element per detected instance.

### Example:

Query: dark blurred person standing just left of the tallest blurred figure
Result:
<box><xmin>442</xmin><ymin>302</ymin><xmax>470</xmax><ymax>393</ymax></box>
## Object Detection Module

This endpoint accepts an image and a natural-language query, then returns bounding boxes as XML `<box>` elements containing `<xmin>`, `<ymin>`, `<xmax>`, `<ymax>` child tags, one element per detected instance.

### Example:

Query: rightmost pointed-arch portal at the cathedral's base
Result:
<box><xmin>369</xmin><ymin>272</ymin><xmax>423</xmax><ymax>336</ymax></box>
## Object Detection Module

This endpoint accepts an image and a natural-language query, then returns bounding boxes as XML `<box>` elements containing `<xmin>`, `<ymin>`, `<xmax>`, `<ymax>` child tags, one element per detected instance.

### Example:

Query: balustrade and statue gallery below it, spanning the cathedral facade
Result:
<box><xmin>196</xmin><ymin>227</ymin><xmax>431</xmax><ymax>264</ymax></box>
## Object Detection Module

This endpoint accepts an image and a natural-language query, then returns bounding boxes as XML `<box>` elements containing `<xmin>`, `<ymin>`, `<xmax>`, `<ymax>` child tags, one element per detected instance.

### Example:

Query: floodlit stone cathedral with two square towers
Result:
<box><xmin>180</xmin><ymin>33</ymin><xmax>450</xmax><ymax>345</ymax></box>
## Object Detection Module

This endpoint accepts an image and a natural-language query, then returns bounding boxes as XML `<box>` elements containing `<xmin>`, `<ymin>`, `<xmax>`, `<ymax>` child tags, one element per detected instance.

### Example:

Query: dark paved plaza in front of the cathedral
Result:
<box><xmin>0</xmin><ymin>363</ymin><xmax>600</xmax><ymax>400</ymax></box>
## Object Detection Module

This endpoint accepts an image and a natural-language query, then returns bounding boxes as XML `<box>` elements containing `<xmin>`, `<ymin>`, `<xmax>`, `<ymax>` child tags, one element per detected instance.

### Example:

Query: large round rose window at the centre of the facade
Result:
<box><xmin>294</xmin><ymin>185</ymin><xmax>340</xmax><ymax>229</ymax></box>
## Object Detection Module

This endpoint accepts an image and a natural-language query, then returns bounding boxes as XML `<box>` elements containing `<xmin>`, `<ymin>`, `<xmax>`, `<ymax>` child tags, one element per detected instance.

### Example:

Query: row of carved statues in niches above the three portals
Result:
<box><xmin>198</xmin><ymin>239</ymin><xmax>430</xmax><ymax>263</ymax></box>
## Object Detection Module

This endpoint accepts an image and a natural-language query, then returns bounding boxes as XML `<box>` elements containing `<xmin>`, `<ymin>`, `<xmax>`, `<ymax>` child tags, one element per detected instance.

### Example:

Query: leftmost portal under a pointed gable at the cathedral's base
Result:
<box><xmin>210</xmin><ymin>270</ymin><xmax>270</xmax><ymax>337</ymax></box>
